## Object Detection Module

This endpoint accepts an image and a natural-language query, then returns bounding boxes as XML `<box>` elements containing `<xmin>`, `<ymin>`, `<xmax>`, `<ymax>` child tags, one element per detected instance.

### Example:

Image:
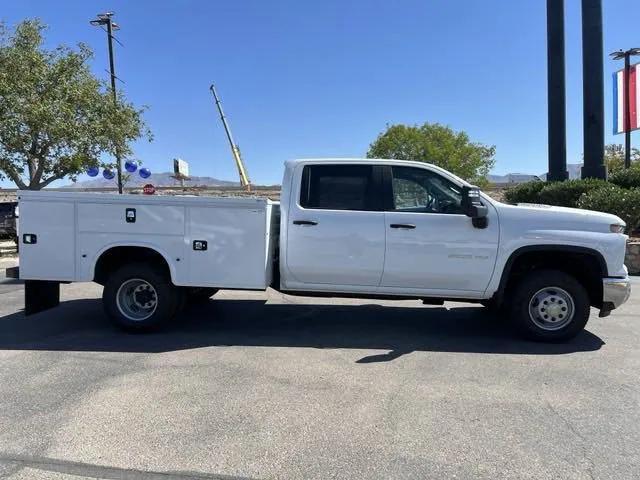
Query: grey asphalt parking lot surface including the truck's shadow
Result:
<box><xmin>0</xmin><ymin>264</ymin><xmax>640</xmax><ymax>480</ymax></box>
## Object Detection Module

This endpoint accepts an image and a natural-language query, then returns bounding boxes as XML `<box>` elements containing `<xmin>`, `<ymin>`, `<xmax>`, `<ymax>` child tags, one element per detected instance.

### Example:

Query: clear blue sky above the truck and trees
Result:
<box><xmin>0</xmin><ymin>0</ymin><xmax>640</xmax><ymax>183</ymax></box>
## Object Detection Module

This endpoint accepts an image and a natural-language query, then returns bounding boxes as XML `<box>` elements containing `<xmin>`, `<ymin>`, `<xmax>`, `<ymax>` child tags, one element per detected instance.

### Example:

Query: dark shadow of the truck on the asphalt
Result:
<box><xmin>0</xmin><ymin>299</ymin><xmax>604</xmax><ymax>363</ymax></box>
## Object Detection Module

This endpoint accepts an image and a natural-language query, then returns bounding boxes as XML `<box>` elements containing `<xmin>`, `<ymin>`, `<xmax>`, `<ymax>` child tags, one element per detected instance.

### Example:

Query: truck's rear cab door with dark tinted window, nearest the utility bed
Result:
<box><xmin>285</xmin><ymin>164</ymin><xmax>385</xmax><ymax>291</ymax></box>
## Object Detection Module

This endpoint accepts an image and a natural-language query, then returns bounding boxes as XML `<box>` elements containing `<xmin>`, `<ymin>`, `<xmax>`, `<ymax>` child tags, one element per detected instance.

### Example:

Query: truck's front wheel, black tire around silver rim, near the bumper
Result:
<box><xmin>510</xmin><ymin>270</ymin><xmax>590</xmax><ymax>342</ymax></box>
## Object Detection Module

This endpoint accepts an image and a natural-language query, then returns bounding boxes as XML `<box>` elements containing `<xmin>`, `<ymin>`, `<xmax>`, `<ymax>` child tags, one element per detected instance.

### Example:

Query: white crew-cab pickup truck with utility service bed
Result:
<box><xmin>9</xmin><ymin>159</ymin><xmax>630</xmax><ymax>341</ymax></box>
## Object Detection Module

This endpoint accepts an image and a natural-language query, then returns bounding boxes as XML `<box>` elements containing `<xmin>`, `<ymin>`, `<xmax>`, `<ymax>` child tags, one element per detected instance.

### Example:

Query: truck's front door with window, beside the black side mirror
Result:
<box><xmin>381</xmin><ymin>166</ymin><xmax>499</xmax><ymax>297</ymax></box>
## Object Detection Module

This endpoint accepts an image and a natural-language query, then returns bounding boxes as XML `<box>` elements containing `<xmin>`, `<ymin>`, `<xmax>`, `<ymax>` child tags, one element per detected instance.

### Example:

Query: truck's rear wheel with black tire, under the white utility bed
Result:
<box><xmin>102</xmin><ymin>263</ymin><xmax>179</xmax><ymax>332</ymax></box>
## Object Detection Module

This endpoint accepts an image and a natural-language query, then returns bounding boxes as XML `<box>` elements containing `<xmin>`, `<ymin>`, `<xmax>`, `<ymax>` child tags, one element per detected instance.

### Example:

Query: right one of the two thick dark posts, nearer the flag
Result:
<box><xmin>582</xmin><ymin>0</ymin><xmax>607</xmax><ymax>179</ymax></box>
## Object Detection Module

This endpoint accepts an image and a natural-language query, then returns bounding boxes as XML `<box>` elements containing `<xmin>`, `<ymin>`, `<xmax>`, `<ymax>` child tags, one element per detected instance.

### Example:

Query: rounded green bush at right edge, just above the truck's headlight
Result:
<box><xmin>578</xmin><ymin>184</ymin><xmax>640</xmax><ymax>233</ymax></box>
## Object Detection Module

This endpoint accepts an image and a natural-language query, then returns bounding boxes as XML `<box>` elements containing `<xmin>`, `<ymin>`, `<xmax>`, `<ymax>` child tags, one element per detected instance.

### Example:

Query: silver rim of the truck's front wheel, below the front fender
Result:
<box><xmin>529</xmin><ymin>287</ymin><xmax>575</xmax><ymax>330</ymax></box>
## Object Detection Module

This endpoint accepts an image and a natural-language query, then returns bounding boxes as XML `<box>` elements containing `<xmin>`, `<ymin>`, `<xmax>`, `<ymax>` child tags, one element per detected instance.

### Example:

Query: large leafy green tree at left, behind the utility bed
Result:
<box><xmin>0</xmin><ymin>20</ymin><xmax>151</xmax><ymax>190</ymax></box>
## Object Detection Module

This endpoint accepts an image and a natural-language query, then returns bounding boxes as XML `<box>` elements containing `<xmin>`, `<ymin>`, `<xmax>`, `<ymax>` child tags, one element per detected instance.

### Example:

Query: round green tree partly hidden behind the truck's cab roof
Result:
<box><xmin>367</xmin><ymin>123</ymin><xmax>496</xmax><ymax>184</ymax></box>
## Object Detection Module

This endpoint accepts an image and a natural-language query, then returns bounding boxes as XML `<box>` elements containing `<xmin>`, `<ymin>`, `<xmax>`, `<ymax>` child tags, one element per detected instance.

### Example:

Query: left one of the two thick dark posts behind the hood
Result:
<box><xmin>547</xmin><ymin>0</ymin><xmax>568</xmax><ymax>182</ymax></box>
